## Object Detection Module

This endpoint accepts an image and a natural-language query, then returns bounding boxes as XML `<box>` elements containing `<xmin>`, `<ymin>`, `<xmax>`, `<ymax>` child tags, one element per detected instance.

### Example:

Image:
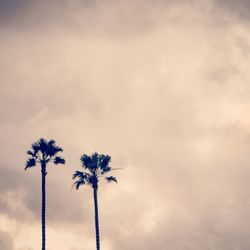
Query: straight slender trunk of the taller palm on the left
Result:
<box><xmin>41</xmin><ymin>163</ymin><xmax>47</xmax><ymax>250</ymax></box>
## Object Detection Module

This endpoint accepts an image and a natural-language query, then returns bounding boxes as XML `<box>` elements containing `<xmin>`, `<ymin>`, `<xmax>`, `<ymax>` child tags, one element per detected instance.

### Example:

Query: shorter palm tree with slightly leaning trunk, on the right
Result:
<box><xmin>73</xmin><ymin>153</ymin><xmax>117</xmax><ymax>250</ymax></box>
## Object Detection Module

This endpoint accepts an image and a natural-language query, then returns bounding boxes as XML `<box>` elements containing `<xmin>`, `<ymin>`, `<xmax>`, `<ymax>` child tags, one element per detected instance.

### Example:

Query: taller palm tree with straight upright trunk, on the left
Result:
<box><xmin>25</xmin><ymin>138</ymin><xmax>65</xmax><ymax>250</ymax></box>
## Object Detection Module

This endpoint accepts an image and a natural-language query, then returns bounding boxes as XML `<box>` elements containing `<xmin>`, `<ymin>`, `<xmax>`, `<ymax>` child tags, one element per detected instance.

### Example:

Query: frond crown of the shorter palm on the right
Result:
<box><xmin>73</xmin><ymin>153</ymin><xmax>117</xmax><ymax>189</ymax></box>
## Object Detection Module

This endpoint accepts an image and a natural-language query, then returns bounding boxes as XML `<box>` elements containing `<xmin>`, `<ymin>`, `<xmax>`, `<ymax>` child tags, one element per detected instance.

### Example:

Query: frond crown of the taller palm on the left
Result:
<box><xmin>25</xmin><ymin>138</ymin><xmax>65</xmax><ymax>170</ymax></box>
